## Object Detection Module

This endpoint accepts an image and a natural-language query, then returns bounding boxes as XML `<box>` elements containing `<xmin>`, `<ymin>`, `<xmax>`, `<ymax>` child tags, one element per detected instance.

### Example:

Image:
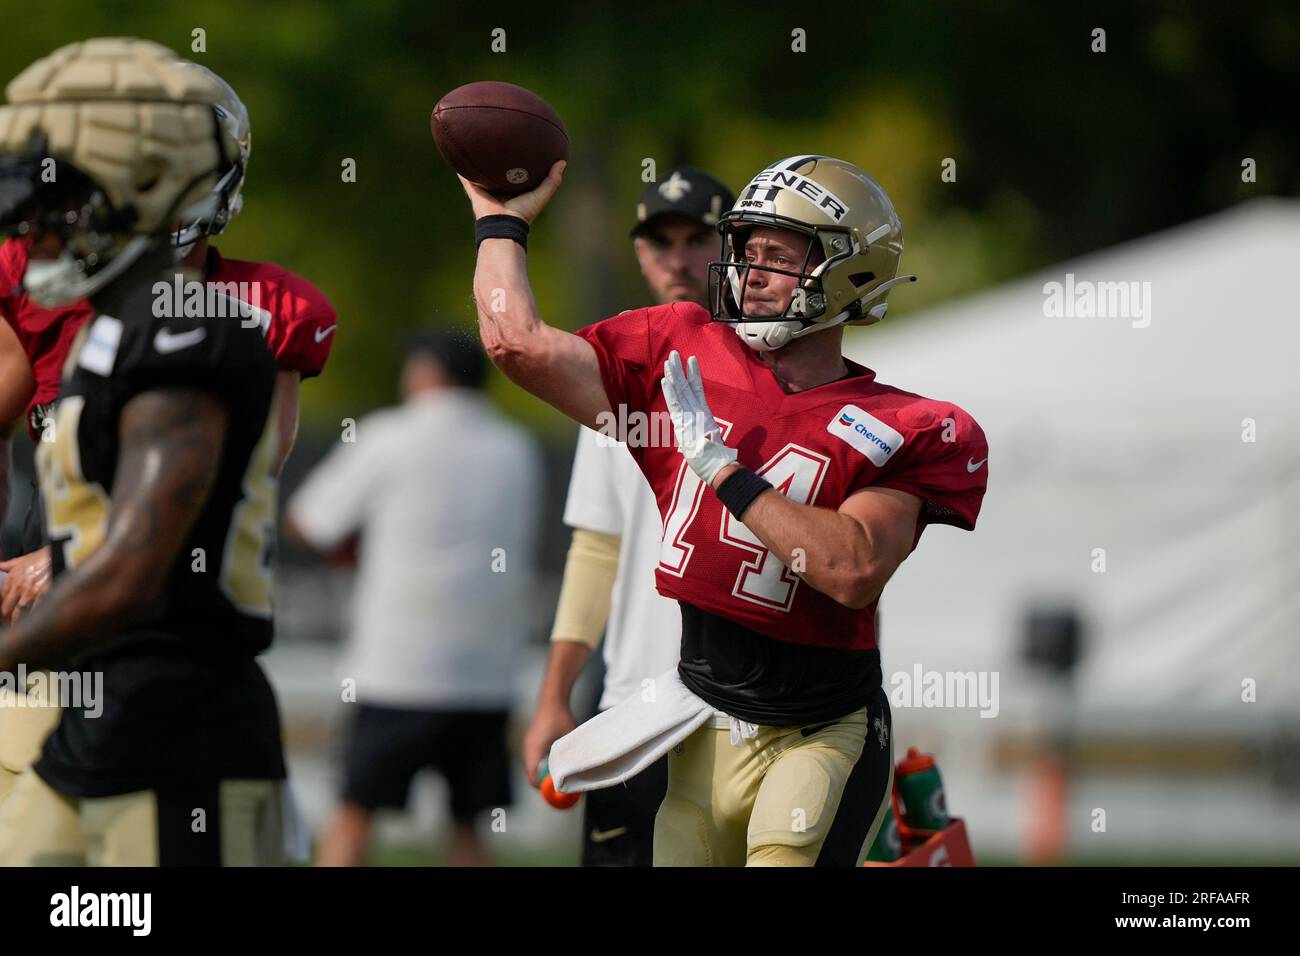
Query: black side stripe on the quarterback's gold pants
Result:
<box><xmin>816</xmin><ymin>687</ymin><xmax>893</xmax><ymax>866</ymax></box>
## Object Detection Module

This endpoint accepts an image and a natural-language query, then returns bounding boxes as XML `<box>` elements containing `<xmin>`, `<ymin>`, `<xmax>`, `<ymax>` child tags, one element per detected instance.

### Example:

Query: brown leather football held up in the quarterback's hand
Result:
<box><xmin>430</xmin><ymin>81</ymin><xmax>569</xmax><ymax>195</ymax></box>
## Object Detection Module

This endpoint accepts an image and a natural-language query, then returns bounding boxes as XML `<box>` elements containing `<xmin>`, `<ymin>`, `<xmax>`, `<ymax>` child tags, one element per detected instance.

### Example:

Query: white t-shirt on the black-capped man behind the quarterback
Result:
<box><xmin>564</xmin><ymin>428</ymin><xmax>681</xmax><ymax>710</ymax></box>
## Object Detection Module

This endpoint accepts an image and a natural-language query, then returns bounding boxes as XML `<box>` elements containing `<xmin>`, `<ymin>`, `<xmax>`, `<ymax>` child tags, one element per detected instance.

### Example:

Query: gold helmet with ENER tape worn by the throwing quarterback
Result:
<box><xmin>709</xmin><ymin>156</ymin><xmax>917</xmax><ymax>351</ymax></box>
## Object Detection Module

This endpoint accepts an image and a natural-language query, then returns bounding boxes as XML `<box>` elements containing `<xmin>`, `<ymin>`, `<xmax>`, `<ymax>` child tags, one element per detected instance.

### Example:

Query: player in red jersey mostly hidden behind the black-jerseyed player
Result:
<box><xmin>0</xmin><ymin>64</ymin><xmax>337</xmax><ymax>816</ymax></box>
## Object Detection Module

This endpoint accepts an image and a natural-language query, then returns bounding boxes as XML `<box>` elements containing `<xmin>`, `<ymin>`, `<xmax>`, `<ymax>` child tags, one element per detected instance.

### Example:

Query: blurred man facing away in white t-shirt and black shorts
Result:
<box><xmin>286</xmin><ymin>330</ymin><xmax>541</xmax><ymax>866</ymax></box>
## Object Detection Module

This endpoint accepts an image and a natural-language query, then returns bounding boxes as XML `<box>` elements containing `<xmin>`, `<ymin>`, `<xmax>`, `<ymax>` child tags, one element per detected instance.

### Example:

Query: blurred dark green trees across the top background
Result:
<box><xmin>0</xmin><ymin>0</ymin><xmax>1300</xmax><ymax>440</ymax></box>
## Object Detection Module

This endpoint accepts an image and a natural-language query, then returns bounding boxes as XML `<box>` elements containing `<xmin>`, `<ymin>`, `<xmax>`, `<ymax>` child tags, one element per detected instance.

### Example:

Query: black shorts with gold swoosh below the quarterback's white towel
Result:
<box><xmin>582</xmin><ymin>754</ymin><xmax>668</xmax><ymax>866</ymax></box>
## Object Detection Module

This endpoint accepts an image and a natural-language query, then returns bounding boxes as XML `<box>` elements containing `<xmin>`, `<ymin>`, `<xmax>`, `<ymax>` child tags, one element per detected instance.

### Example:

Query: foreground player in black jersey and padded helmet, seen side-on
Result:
<box><xmin>0</xmin><ymin>39</ymin><xmax>285</xmax><ymax>865</ymax></box>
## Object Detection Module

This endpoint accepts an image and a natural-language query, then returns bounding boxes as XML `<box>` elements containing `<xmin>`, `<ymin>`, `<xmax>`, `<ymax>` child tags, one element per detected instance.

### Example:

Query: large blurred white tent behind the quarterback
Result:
<box><xmin>846</xmin><ymin>200</ymin><xmax>1300</xmax><ymax>858</ymax></box>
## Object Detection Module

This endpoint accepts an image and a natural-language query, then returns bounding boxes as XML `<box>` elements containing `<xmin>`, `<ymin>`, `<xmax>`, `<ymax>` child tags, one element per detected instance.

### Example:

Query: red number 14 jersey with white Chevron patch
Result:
<box><xmin>577</xmin><ymin>303</ymin><xmax>988</xmax><ymax>650</ymax></box>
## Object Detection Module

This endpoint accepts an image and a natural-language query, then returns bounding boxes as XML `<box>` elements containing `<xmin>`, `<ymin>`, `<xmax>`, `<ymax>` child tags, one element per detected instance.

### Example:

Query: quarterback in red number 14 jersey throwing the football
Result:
<box><xmin>463</xmin><ymin>156</ymin><xmax>988</xmax><ymax>865</ymax></box>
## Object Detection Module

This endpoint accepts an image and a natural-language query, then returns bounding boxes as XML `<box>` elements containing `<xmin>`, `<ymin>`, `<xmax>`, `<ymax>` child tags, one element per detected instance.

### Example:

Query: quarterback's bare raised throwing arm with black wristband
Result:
<box><xmin>460</xmin><ymin>161</ymin><xmax>610</xmax><ymax>428</ymax></box>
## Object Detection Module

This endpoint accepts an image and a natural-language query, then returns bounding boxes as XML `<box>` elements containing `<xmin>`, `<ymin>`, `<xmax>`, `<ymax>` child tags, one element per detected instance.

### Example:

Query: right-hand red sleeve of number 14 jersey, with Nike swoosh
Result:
<box><xmin>871</xmin><ymin>403</ymin><xmax>988</xmax><ymax>546</ymax></box>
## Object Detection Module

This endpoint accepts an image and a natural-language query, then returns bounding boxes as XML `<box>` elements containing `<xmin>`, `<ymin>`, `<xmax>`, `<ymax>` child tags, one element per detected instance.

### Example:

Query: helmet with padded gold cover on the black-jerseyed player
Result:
<box><xmin>0</xmin><ymin>39</ymin><xmax>241</xmax><ymax>306</ymax></box>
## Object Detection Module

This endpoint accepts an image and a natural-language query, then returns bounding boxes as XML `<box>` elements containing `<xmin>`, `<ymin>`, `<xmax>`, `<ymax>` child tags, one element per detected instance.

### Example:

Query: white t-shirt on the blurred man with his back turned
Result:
<box><xmin>289</xmin><ymin>389</ymin><xmax>541</xmax><ymax>710</ymax></box>
